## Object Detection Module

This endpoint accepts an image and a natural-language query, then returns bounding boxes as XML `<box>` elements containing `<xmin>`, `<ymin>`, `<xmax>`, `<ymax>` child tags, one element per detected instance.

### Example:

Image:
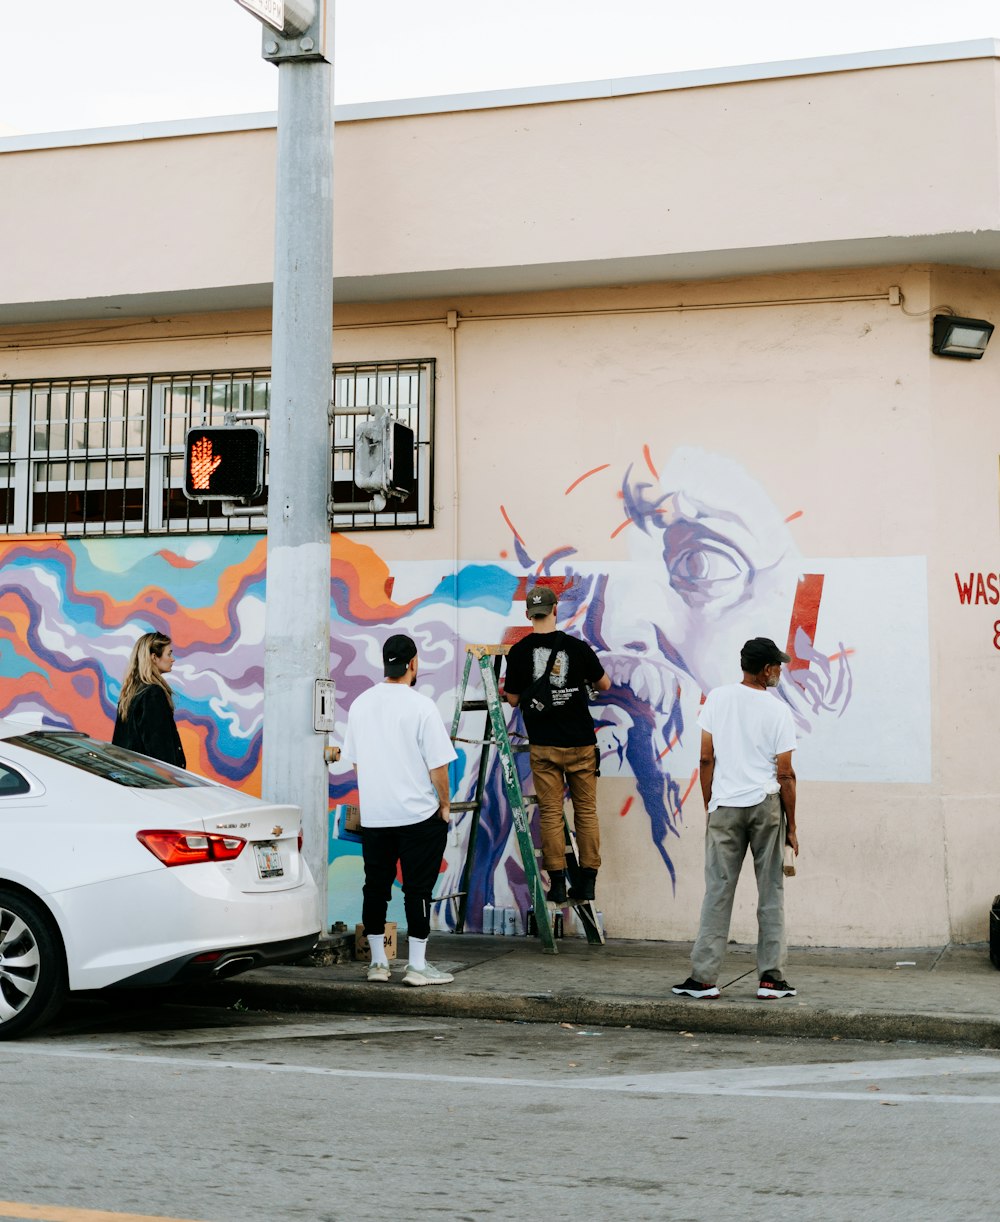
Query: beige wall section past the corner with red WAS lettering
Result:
<box><xmin>928</xmin><ymin>268</ymin><xmax>1000</xmax><ymax>941</ymax></box>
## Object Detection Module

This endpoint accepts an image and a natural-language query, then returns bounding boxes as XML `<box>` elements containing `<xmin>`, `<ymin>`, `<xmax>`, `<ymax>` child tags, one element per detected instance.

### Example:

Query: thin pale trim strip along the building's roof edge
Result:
<box><xmin>0</xmin><ymin>38</ymin><xmax>1000</xmax><ymax>153</ymax></box>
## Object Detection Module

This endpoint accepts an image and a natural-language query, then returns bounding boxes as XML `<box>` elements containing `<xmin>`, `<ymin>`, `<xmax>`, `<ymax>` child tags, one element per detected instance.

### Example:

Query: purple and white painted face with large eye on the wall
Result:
<box><xmin>418</xmin><ymin>448</ymin><xmax>851</xmax><ymax>919</ymax></box>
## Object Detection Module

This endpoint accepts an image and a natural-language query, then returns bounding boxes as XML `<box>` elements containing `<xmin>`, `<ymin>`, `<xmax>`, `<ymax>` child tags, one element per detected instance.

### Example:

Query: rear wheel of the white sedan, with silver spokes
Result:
<box><xmin>0</xmin><ymin>888</ymin><xmax>66</xmax><ymax>1040</ymax></box>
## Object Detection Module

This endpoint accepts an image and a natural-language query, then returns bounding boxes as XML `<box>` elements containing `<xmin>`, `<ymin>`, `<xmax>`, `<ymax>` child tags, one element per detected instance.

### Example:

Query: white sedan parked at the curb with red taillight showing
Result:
<box><xmin>0</xmin><ymin>720</ymin><xmax>319</xmax><ymax>1040</ymax></box>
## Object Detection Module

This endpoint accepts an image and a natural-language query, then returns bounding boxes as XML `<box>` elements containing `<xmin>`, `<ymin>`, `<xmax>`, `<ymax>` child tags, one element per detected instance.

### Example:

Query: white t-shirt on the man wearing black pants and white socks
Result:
<box><xmin>341</xmin><ymin>683</ymin><xmax>456</xmax><ymax>827</ymax></box>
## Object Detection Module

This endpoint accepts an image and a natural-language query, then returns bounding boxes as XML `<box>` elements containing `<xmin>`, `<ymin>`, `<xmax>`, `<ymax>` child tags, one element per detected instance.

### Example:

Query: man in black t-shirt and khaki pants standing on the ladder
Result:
<box><xmin>504</xmin><ymin>585</ymin><xmax>611</xmax><ymax>904</ymax></box>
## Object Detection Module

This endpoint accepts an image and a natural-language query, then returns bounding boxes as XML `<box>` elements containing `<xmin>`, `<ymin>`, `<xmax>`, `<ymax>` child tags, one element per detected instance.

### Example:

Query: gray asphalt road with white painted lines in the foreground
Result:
<box><xmin>0</xmin><ymin>1002</ymin><xmax>1000</xmax><ymax>1222</ymax></box>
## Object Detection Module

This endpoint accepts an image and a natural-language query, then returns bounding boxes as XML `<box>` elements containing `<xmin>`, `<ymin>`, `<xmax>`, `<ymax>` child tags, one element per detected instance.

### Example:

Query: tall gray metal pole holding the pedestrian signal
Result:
<box><xmin>240</xmin><ymin>0</ymin><xmax>334</xmax><ymax>929</ymax></box>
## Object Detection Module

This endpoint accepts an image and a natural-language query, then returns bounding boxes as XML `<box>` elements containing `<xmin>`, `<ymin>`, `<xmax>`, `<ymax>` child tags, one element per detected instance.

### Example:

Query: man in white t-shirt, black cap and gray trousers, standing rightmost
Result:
<box><xmin>672</xmin><ymin>637</ymin><xmax>798</xmax><ymax>1000</ymax></box>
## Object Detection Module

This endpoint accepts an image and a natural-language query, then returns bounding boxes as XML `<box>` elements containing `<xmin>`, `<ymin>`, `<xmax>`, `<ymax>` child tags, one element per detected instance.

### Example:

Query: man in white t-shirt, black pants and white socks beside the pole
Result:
<box><xmin>341</xmin><ymin>633</ymin><xmax>456</xmax><ymax>985</ymax></box>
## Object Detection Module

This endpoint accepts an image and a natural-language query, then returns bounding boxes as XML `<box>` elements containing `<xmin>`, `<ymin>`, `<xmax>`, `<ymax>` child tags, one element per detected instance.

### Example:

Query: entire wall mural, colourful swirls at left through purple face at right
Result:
<box><xmin>0</xmin><ymin>448</ymin><xmax>929</xmax><ymax>929</ymax></box>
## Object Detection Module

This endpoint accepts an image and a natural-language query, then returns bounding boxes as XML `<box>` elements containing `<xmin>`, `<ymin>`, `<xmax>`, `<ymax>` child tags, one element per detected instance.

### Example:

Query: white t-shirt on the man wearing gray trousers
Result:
<box><xmin>698</xmin><ymin>683</ymin><xmax>795</xmax><ymax>811</ymax></box>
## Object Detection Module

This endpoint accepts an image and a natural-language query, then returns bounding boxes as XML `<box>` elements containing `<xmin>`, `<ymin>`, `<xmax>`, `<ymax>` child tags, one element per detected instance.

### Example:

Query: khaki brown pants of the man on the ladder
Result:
<box><xmin>528</xmin><ymin>745</ymin><xmax>600</xmax><ymax>870</ymax></box>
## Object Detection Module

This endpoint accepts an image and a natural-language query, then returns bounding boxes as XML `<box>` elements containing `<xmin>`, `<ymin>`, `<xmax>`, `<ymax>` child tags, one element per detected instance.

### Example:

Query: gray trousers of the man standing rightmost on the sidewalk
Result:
<box><xmin>691</xmin><ymin>793</ymin><xmax>785</xmax><ymax>985</ymax></box>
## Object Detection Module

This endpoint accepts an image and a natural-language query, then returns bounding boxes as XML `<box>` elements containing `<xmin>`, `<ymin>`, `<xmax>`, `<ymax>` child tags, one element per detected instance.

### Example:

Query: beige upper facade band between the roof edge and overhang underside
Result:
<box><xmin>0</xmin><ymin>44</ymin><xmax>1000</xmax><ymax>321</ymax></box>
